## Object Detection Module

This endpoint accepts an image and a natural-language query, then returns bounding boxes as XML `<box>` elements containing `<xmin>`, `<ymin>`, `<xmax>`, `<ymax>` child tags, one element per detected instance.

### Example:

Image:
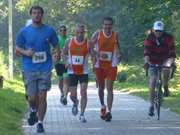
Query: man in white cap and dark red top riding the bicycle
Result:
<box><xmin>144</xmin><ymin>21</ymin><xmax>176</xmax><ymax>116</ymax></box>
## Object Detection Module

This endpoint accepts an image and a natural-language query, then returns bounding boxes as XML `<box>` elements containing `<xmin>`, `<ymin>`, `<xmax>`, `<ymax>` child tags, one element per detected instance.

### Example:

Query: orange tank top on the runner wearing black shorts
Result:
<box><xmin>69</xmin><ymin>38</ymin><xmax>88</xmax><ymax>75</ymax></box>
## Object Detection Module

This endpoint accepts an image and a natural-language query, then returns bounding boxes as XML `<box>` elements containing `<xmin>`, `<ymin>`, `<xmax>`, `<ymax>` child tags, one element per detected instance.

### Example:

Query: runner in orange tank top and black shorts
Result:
<box><xmin>63</xmin><ymin>24</ymin><xmax>90</xmax><ymax>122</ymax></box>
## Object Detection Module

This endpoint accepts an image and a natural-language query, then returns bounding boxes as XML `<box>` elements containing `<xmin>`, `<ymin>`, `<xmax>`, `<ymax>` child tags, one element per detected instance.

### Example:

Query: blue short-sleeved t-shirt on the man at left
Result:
<box><xmin>16</xmin><ymin>24</ymin><xmax>58</xmax><ymax>72</ymax></box>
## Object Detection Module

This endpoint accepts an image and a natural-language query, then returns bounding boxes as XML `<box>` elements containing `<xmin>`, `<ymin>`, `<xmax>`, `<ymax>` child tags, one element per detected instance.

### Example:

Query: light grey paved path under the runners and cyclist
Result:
<box><xmin>23</xmin><ymin>84</ymin><xmax>180</xmax><ymax>135</ymax></box>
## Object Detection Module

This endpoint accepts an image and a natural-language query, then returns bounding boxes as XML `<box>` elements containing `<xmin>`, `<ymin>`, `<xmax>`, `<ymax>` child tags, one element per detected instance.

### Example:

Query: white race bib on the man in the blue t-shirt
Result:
<box><xmin>32</xmin><ymin>52</ymin><xmax>47</xmax><ymax>63</ymax></box>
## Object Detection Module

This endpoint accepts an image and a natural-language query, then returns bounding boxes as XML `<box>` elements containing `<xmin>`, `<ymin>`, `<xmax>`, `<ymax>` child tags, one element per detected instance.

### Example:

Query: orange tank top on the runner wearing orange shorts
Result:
<box><xmin>98</xmin><ymin>31</ymin><xmax>116</xmax><ymax>68</ymax></box>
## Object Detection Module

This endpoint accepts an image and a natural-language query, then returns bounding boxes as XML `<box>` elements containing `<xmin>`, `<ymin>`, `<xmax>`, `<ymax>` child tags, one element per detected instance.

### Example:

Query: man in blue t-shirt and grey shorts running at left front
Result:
<box><xmin>16</xmin><ymin>6</ymin><xmax>60</xmax><ymax>133</ymax></box>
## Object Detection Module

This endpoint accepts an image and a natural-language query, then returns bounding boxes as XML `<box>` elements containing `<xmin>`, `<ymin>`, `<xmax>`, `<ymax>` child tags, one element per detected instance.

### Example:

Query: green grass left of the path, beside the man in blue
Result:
<box><xmin>0</xmin><ymin>77</ymin><xmax>26</xmax><ymax>135</ymax></box>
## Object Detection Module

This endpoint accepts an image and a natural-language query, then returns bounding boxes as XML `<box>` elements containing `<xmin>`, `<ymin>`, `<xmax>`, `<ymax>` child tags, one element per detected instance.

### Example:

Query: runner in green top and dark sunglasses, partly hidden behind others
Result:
<box><xmin>55</xmin><ymin>25</ymin><xmax>68</xmax><ymax>105</ymax></box>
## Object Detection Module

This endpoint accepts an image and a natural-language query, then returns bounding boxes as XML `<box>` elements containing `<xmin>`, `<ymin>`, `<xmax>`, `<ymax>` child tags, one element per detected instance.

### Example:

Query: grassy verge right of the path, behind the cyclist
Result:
<box><xmin>114</xmin><ymin>57</ymin><xmax>180</xmax><ymax>114</ymax></box>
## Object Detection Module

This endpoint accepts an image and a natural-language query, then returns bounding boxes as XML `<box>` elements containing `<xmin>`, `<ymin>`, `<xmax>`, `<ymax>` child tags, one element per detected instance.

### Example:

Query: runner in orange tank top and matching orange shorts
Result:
<box><xmin>91</xmin><ymin>17</ymin><xmax>120</xmax><ymax>121</ymax></box>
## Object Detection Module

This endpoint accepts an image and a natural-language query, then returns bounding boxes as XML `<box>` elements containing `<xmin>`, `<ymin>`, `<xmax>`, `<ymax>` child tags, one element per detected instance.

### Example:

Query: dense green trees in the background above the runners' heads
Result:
<box><xmin>0</xmin><ymin>0</ymin><xmax>180</xmax><ymax>61</ymax></box>
